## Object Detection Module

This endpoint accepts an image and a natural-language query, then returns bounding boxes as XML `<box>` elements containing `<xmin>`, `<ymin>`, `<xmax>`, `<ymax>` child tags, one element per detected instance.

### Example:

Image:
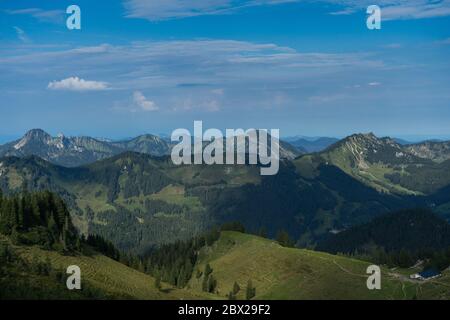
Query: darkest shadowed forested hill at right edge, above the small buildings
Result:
<box><xmin>316</xmin><ymin>209</ymin><xmax>450</xmax><ymax>270</ymax></box>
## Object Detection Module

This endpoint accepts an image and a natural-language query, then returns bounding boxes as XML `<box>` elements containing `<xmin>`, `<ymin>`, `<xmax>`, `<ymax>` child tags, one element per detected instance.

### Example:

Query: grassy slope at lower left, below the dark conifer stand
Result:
<box><xmin>0</xmin><ymin>236</ymin><xmax>210</xmax><ymax>300</ymax></box>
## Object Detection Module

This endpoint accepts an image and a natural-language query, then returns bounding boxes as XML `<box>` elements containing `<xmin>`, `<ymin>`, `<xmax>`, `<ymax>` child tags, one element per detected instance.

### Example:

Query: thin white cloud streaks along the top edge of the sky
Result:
<box><xmin>125</xmin><ymin>0</ymin><xmax>450</xmax><ymax>21</ymax></box>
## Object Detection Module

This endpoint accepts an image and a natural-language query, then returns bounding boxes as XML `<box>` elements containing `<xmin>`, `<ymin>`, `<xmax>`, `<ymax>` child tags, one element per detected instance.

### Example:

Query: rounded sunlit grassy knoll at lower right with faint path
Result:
<box><xmin>190</xmin><ymin>232</ymin><xmax>450</xmax><ymax>299</ymax></box>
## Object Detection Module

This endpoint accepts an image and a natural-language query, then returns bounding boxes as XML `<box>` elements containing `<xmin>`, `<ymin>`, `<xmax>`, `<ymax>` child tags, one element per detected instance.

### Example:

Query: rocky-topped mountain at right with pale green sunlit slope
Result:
<box><xmin>295</xmin><ymin>134</ymin><xmax>450</xmax><ymax>195</ymax></box>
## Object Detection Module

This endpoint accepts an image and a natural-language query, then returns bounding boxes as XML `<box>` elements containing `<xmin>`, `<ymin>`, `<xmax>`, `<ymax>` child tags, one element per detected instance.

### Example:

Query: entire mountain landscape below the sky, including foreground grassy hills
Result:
<box><xmin>0</xmin><ymin>130</ymin><xmax>450</xmax><ymax>299</ymax></box>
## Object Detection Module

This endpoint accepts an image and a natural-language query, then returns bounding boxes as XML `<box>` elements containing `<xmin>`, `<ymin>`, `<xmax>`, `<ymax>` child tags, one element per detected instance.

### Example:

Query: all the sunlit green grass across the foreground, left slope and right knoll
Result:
<box><xmin>0</xmin><ymin>231</ymin><xmax>450</xmax><ymax>300</ymax></box>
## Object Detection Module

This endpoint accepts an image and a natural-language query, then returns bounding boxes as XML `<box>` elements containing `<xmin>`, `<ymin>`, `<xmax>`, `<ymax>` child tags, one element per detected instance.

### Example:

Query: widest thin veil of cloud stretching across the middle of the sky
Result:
<box><xmin>0</xmin><ymin>39</ymin><xmax>396</xmax><ymax>114</ymax></box>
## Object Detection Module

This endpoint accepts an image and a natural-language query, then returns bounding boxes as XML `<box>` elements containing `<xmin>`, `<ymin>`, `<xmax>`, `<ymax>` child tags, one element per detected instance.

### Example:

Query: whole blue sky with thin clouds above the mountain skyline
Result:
<box><xmin>0</xmin><ymin>0</ymin><xmax>450</xmax><ymax>142</ymax></box>
